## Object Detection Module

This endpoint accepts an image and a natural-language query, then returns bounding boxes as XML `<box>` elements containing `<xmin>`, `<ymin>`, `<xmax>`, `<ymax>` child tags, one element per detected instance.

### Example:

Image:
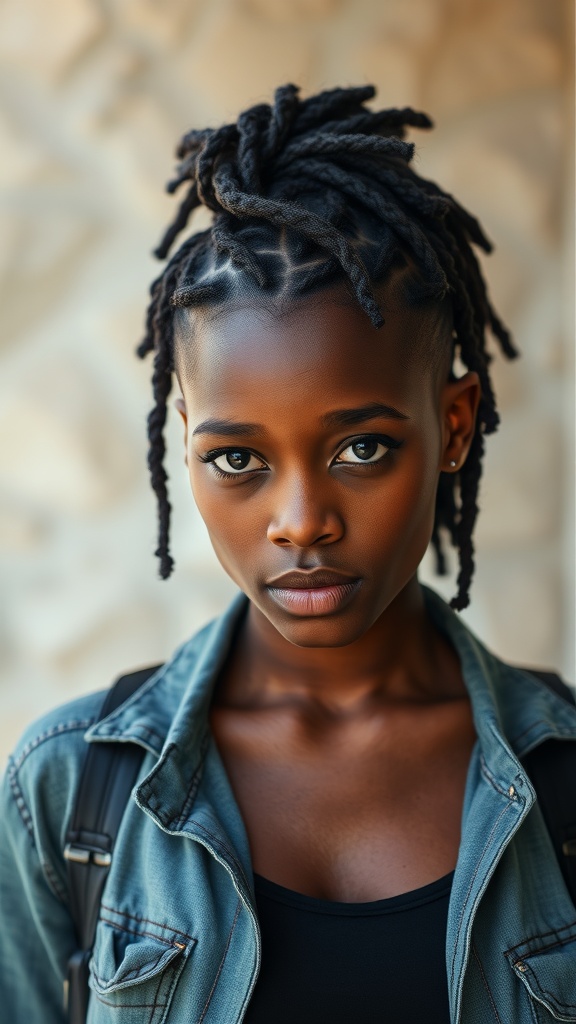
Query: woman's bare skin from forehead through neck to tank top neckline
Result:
<box><xmin>176</xmin><ymin>290</ymin><xmax>480</xmax><ymax>902</ymax></box>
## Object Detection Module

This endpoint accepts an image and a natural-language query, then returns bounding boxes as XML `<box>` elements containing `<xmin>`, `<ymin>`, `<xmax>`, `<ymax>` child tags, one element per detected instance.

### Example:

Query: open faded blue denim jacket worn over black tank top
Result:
<box><xmin>0</xmin><ymin>591</ymin><xmax>576</xmax><ymax>1024</ymax></box>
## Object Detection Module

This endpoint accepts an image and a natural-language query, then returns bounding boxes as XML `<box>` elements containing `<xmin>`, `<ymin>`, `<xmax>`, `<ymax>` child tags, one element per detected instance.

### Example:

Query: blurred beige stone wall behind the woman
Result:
<box><xmin>0</xmin><ymin>0</ymin><xmax>574</xmax><ymax>762</ymax></box>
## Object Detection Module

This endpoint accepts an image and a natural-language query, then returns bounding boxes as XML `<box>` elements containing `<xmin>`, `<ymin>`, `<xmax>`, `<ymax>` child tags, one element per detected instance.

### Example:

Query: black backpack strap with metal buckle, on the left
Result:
<box><xmin>64</xmin><ymin>665</ymin><xmax>160</xmax><ymax>1024</ymax></box>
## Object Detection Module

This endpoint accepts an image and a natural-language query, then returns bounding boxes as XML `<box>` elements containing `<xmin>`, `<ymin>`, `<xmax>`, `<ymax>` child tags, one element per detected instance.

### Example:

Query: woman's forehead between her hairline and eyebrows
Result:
<box><xmin>176</xmin><ymin>292</ymin><xmax>439</xmax><ymax>410</ymax></box>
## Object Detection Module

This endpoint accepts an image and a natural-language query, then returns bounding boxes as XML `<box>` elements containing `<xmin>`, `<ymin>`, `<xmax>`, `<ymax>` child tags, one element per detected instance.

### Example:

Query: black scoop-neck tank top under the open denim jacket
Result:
<box><xmin>244</xmin><ymin>872</ymin><xmax>454</xmax><ymax>1024</ymax></box>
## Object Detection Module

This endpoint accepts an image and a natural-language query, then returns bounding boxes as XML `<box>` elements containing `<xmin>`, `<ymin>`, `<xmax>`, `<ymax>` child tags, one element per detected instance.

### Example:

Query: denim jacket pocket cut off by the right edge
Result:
<box><xmin>506</xmin><ymin>925</ymin><xmax>576</xmax><ymax>1024</ymax></box>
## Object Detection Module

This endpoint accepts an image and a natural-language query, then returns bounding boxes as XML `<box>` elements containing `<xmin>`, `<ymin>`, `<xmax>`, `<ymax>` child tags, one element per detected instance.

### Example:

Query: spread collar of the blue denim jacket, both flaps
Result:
<box><xmin>86</xmin><ymin>587</ymin><xmax>576</xmax><ymax>809</ymax></box>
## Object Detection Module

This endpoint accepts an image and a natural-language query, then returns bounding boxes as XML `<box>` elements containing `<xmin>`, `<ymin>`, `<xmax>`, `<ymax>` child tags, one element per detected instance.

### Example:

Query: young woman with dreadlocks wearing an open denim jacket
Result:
<box><xmin>0</xmin><ymin>86</ymin><xmax>576</xmax><ymax>1024</ymax></box>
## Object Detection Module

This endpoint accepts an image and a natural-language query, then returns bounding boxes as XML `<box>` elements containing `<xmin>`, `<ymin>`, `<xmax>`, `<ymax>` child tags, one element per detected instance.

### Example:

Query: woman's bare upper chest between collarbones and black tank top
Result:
<box><xmin>208</xmin><ymin>703</ymin><xmax>475</xmax><ymax>901</ymax></box>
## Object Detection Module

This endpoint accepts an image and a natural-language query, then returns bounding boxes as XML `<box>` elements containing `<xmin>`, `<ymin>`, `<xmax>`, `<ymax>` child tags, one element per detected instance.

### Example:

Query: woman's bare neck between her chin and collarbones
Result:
<box><xmin>220</xmin><ymin>578</ymin><xmax>461</xmax><ymax>711</ymax></box>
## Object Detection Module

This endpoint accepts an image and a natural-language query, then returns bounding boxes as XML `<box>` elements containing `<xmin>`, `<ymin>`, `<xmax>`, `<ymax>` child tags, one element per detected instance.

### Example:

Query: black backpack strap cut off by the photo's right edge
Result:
<box><xmin>524</xmin><ymin>669</ymin><xmax>576</xmax><ymax>906</ymax></box>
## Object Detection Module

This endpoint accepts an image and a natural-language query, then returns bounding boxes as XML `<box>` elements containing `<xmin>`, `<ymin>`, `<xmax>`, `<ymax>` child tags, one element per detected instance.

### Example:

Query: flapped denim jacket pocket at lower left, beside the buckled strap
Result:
<box><xmin>88</xmin><ymin>921</ymin><xmax>196</xmax><ymax>1024</ymax></box>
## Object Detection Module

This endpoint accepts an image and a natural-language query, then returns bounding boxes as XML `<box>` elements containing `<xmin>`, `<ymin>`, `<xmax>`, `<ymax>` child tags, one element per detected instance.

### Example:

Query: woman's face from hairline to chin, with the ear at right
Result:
<box><xmin>176</xmin><ymin>291</ymin><xmax>479</xmax><ymax>647</ymax></box>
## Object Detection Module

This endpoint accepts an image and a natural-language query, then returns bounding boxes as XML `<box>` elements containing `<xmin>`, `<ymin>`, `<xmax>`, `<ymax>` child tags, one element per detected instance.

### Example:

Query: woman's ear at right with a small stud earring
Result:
<box><xmin>440</xmin><ymin>371</ymin><xmax>481</xmax><ymax>473</ymax></box>
